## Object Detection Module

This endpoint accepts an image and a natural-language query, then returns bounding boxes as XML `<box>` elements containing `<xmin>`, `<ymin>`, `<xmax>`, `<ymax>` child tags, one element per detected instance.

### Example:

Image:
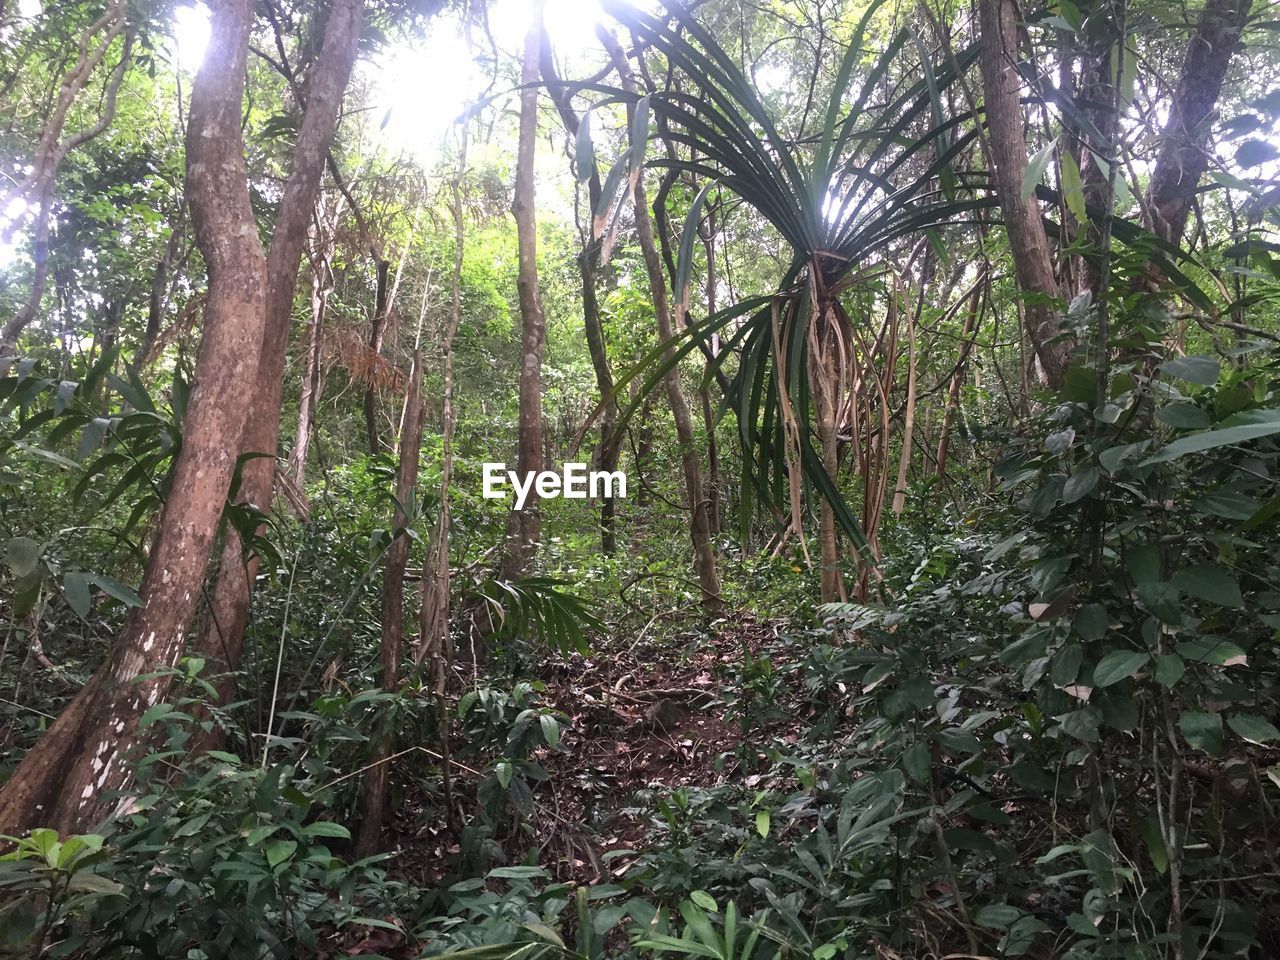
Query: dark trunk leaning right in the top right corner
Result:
<box><xmin>1147</xmin><ymin>0</ymin><xmax>1252</xmax><ymax>243</ymax></box>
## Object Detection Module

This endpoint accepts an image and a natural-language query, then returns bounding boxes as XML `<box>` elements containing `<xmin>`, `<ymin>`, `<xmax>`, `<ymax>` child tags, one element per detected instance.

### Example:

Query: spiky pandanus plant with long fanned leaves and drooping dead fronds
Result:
<box><xmin>579</xmin><ymin>0</ymin><xmax>993</xmax><ymax>600</ymax></box>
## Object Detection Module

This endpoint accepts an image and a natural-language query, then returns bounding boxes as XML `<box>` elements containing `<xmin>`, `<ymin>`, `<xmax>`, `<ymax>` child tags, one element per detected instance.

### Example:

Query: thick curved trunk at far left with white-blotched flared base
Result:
<box><xmin>0</xmin><ymin>0</ymin><xmax>266</xmax><ymax>833</ymax></box>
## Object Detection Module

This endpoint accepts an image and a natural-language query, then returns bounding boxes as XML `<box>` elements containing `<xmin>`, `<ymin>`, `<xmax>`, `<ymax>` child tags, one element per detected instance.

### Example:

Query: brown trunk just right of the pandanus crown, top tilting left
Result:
<box><xmin>978</xmin><ymin>0</ymin><xmax>1068</xmax><ymax>388</ymax></box>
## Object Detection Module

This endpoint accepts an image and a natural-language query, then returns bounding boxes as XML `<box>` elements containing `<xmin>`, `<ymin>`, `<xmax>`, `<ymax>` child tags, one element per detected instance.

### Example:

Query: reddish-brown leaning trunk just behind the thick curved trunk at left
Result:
<box><xmin>186</xmin><ymin>0</ymin><xmax>362</xmax><ymax>750</ymax></box>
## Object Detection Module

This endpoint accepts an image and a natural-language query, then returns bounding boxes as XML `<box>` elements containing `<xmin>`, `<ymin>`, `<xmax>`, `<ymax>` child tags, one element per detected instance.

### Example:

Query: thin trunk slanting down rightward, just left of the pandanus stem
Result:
<box><xmin>598</xmin><ymin>28</ymin><xmax>721</xmax><ymax>613</ymax></box>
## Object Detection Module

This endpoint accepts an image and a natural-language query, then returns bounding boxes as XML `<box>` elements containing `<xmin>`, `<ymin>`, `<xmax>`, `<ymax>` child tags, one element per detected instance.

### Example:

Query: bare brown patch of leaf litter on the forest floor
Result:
<box><xmin>397</xmin><ymin>613</ymin><xmax>800</xmax><ymax>883</ymax></box>
